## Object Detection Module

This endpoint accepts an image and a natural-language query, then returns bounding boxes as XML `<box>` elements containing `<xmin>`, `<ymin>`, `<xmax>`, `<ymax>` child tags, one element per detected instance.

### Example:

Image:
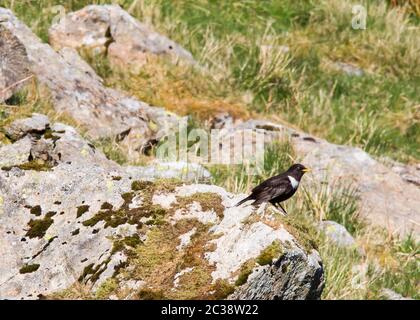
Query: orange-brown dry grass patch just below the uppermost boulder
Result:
<box><xmin>107</xmin><ymin>56</ymin><xmax>250</xmax><ymax>121</ymax></box>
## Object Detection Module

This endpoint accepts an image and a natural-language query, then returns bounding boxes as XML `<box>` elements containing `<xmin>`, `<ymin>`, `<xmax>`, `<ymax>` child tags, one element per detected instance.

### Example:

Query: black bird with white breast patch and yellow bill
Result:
<box><xmin>236</xmin><ymin>163</ymin><xmax>311</xmax><ymax>214</ymax></box>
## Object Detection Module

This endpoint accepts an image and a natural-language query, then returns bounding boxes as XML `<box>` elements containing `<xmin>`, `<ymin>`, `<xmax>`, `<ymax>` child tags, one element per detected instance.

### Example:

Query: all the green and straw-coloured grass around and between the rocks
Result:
<box><xmin>0</xmin><ymin>0</ymin><xmax>420</xmax><ymax>299</ymax></box>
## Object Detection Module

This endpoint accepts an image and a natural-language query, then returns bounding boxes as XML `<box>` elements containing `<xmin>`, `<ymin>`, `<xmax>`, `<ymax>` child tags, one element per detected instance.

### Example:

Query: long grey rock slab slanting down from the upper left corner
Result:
<box><xmin>0</xmin><ymin>8</ymin><xmax>177</xmax><ymax>157</ymax></box>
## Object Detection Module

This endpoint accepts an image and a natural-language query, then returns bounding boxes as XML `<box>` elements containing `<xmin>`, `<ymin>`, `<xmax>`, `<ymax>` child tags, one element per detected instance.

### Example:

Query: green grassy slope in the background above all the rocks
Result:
<box><xmin>0</xmin><ymin>0</ymin><xmax>420</xmax><ymax>161</ymax></box>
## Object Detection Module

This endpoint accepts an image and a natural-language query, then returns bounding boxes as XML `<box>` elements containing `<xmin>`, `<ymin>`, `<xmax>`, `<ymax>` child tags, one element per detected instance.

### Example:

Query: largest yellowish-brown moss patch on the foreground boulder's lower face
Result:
<box><xmin>115</xmin><ymin>219</ymin><xmax>226</xmax><ymax>300</ymax></box>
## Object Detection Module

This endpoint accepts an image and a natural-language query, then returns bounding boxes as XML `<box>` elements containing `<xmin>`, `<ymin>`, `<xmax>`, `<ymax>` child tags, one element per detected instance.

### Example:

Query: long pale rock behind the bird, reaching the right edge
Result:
<box><xmin>218</xmin><ymin>120</ymin><xmax>420</xmax><ymax>237</ymax></box>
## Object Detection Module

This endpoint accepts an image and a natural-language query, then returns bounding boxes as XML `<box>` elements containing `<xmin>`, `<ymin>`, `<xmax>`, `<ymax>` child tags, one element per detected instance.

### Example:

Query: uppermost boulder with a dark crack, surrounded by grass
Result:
<box><xmin>49</xmin><ymin>5</ymin><xmax>194</xmax><ymax>68</ymax></box>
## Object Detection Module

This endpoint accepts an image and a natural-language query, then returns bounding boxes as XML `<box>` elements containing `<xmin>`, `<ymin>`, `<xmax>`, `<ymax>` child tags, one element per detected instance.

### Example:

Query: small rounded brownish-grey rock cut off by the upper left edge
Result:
<box><xmin>0</xmin><ymin>25</ymin><xmax>31</xmax><ymax>102</ymax></box>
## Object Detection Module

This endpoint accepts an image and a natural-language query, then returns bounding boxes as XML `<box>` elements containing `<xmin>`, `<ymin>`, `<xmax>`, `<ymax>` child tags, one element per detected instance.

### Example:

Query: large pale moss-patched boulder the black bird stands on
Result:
<box><xmin>0</xmin><ymin>114</ymin><xmax>323</xmax><ymax>299</ymax></box>
